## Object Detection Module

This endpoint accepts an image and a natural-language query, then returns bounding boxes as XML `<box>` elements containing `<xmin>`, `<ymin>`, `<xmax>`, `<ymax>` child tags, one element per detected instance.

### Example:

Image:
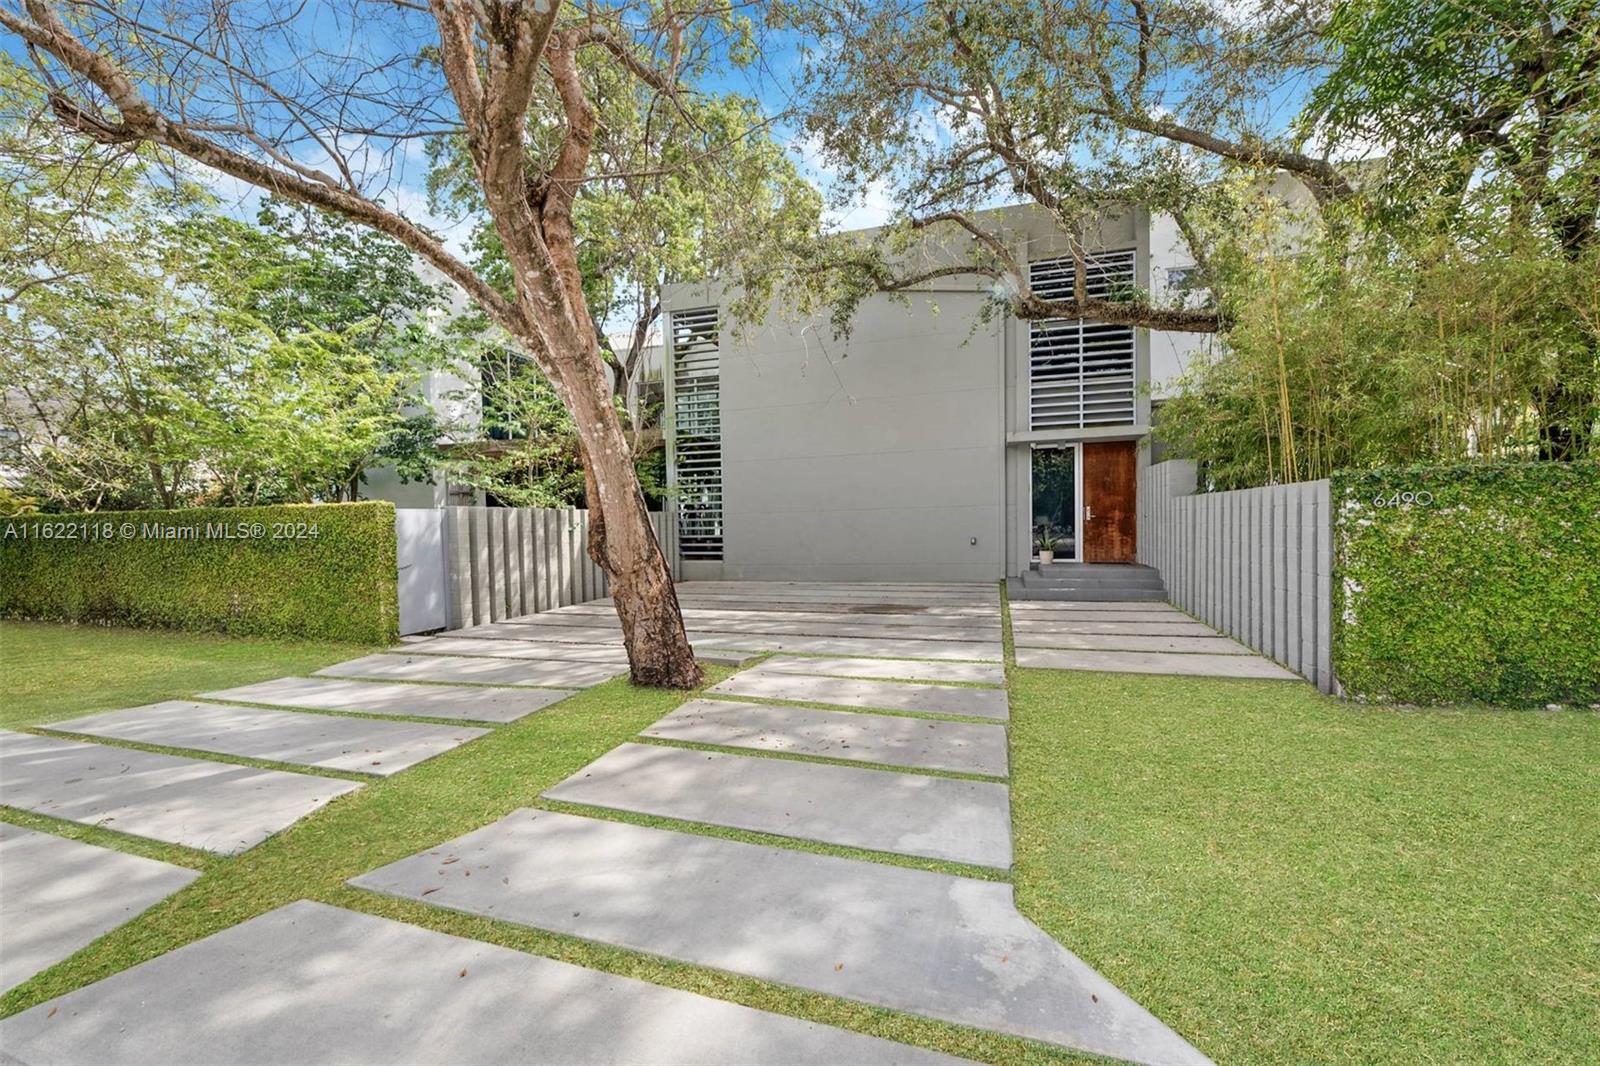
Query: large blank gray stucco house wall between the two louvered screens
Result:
<box><xmin>672</xmin><ymin>281</ymin><xmax>1005</xmax><ymax>581</ymax></box>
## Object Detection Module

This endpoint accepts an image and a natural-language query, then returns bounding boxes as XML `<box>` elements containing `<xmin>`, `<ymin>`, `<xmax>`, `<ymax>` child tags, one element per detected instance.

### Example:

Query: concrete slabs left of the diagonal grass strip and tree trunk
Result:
<box><xmin>0</xmin><ymin>633</ymin><xmax>626</xmax><ymax>998</ymax></box>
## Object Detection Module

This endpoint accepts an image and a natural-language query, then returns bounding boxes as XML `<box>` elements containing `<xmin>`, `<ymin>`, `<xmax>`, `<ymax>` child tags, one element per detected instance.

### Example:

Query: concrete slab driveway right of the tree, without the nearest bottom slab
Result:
<box><xmin>350</xmin><ymin>583</ymin><xmax>1205</xmax><ymax>1063</ymax></box>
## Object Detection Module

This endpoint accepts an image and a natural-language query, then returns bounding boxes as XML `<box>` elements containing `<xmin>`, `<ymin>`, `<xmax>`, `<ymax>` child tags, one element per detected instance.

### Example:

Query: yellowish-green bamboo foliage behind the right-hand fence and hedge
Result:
<box><xmin>1160</xmin><ymin>192</ymin><xmax>1600</xmax><ymax>488</ymax></box>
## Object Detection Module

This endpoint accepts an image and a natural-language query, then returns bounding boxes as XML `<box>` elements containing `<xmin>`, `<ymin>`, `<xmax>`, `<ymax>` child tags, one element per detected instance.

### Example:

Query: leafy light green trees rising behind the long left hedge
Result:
<box><xmin>0</xmin><ymin>126</ymin><xmax>446</xmax><ymax>511</ymax></box>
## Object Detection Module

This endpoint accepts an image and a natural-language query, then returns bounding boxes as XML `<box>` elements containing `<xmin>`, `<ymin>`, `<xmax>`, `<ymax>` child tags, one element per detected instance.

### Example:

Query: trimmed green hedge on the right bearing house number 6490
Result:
<box><xmin>1333</xmin><ymin>463</ymin><xmax>1600</xmax><ymax>704</ymax></box>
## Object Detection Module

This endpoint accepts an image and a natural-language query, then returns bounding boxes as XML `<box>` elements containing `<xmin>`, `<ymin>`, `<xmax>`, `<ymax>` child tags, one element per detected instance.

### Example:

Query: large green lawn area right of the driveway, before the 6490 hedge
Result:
<box><xmin>1011</xmin><ymin>669</ymin><xmax>1600</xmax><ymax>1063</ymax></box>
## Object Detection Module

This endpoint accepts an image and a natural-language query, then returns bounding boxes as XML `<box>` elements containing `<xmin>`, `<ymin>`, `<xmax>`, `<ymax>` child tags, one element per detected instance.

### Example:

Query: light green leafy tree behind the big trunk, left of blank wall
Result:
<box><xmin>429</xmin><ymin>69</ymin><xmax>821</xmax><ymax>506</ymax></box>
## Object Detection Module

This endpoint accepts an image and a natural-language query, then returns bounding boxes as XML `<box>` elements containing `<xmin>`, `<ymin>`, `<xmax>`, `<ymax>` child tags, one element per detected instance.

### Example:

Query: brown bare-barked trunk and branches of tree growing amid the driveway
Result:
<box><xmin>0</xmin><ymin>0</ymin><xmax>702</xmax><ymax>688</ymax></box>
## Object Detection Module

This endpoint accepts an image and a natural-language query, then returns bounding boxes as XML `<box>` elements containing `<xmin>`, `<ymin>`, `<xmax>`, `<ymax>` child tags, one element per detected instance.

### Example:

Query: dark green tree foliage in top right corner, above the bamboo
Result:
<box><xmin>1299</xmin><ymin>0</ymin><xmax>1600</xmax><ymax>253</ymax></box>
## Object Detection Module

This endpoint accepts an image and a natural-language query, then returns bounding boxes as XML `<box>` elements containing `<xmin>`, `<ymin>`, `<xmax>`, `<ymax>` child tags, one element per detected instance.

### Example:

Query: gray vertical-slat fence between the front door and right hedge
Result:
<box><xmin>1139</xmin><ymin>461</ymin><xmax>1338</xmax><ymax>691</ymax></box>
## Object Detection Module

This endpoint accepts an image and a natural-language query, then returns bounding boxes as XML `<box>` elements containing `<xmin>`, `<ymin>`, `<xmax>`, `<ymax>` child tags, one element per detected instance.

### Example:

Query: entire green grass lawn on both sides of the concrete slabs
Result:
<box><xmin>0</xmin><ymin>624</ymin><xmax>1600</xmax><ymax>1063</ymax></box>
